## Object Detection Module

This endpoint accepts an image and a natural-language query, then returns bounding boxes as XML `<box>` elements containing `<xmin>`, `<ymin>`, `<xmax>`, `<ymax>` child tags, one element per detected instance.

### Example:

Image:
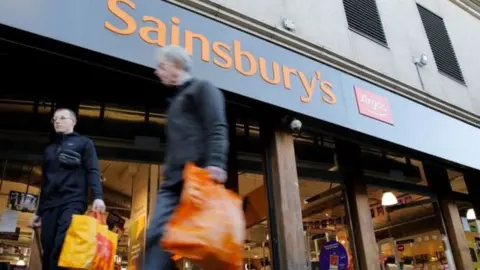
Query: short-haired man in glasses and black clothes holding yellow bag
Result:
<box><xmin>32</xmin><ymin>109</ymin><xmax>105</xmax><ymax>270</ymax></box>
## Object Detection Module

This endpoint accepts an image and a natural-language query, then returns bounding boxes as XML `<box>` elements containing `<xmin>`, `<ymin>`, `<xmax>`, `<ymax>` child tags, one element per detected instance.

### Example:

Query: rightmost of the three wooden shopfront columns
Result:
<box><xmin>423</xmin><ymin>161</ymin><xmax>473</xmax><ymax>270</ymax></box>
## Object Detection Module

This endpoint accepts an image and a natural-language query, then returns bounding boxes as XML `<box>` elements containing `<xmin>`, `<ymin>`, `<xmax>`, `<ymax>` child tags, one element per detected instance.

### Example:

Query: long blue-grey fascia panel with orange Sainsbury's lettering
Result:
<box><xmin>0</xmin><ymin>0</ymin><xmax>480</xmax><ymax>169</ymax></box>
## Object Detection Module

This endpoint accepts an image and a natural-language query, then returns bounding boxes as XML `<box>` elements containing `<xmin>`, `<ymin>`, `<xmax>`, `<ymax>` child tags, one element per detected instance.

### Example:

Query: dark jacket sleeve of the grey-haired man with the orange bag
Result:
<box><xmin>196</xmin><ymin>81</ymin><xmax>229</xmax><ymax>170</ymax></box>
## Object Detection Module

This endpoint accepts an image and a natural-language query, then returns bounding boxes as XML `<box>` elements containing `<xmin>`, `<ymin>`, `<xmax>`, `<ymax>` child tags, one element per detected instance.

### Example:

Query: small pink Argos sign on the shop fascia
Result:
<box><xmin>353</xmin><ymin>86</ymin><xmax>393</xmax><ymax>125</ymax></box>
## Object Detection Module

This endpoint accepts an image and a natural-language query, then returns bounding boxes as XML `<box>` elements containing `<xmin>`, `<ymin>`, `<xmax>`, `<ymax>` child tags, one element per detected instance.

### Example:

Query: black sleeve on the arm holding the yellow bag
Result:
<box><xmin>83</xmin><ymin>139</ymin><xmax>103</xmax><ymax>200</ymax></box>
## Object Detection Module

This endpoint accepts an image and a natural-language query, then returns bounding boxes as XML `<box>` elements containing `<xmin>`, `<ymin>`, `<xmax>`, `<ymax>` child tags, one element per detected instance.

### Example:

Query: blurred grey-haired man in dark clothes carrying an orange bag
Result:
<box><xmin>145</xmin><ymin>46</ymin><xmax>229</xmax><ymax>270</ymax></box>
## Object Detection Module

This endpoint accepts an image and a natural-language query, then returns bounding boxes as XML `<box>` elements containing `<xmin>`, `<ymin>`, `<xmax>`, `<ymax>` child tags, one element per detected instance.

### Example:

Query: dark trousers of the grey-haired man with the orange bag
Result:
<box><xmin>143</xmin><ymin>179</ymin><xmax>183</xmax><ymax>270</ymax></box>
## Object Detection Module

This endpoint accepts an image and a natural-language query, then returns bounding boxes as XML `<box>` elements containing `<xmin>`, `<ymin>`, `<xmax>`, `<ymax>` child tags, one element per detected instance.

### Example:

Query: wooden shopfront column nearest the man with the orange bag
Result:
<box><xmin>260</xmin><ymin>120</ymin><xmax>307</xmax><ymax>270</ymax></box>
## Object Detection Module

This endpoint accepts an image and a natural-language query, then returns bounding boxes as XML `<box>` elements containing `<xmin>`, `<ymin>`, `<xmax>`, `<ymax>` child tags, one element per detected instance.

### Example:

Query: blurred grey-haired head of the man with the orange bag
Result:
<box><xmin>155</xmin><ymin>46</ymin><xmax>193</xmax><ymax>86</ymax></box>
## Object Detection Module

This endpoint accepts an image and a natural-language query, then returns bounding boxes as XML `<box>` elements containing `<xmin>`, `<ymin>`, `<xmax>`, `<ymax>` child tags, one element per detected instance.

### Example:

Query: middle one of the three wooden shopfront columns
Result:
<box><xmin>335</xmin><ymin>140</ymin><xmax>380</xmax><ymax>270</ymax></box>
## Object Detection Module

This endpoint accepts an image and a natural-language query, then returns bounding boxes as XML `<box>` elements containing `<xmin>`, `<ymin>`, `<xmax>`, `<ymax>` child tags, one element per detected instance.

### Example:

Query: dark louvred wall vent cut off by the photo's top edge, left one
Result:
<box><xmin>343</xmin><ymin>0</ymin><xmax>387</xmax><ymax>45</ymax></box>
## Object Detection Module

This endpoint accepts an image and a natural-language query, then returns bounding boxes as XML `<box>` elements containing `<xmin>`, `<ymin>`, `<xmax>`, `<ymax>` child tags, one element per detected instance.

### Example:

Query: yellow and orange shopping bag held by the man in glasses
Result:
<box><xmin>58</xmin><ymin>212</ymin><xmax>118</xmax><ymax>270</ymax></box>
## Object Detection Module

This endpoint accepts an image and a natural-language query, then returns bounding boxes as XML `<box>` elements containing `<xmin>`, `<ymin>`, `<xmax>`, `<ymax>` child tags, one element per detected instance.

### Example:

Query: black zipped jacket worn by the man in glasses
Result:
<box><xmin>37</xmin><ymin>133</ymin><xmax>103</xmax><ymax>216</ymax></box>
